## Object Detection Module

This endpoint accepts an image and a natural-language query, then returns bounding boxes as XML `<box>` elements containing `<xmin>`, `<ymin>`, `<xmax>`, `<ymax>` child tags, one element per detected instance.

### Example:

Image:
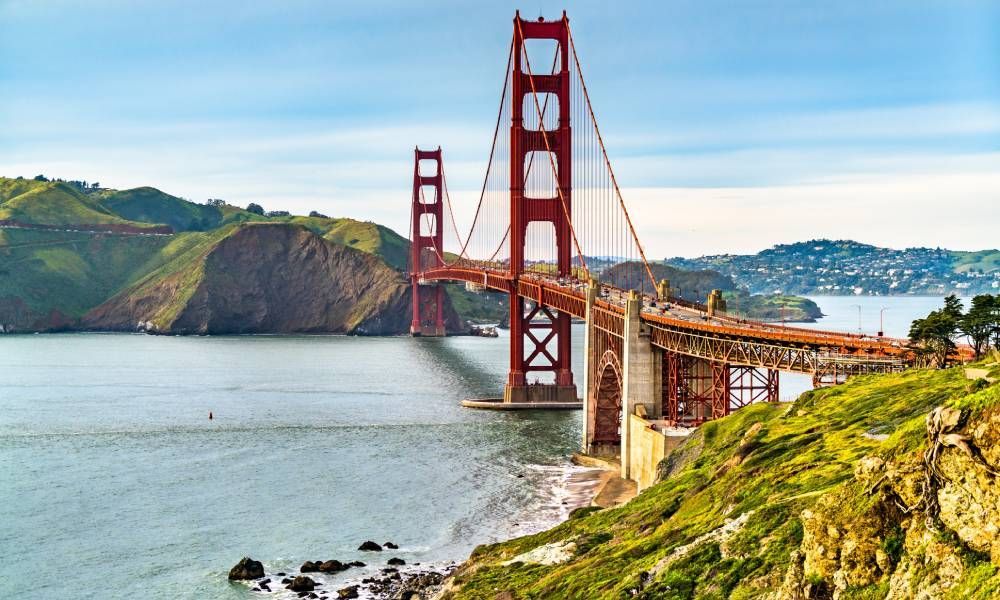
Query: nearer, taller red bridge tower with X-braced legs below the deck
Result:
<box><xmin>504</xmin><ymin>12</ymin><xmax>577</xmax><ymax>402</ymax></box>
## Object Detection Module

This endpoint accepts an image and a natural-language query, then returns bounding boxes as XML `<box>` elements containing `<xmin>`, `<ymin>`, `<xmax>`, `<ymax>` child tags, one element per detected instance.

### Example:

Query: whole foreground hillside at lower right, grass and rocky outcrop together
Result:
<box><xmin>444</xmin><ymin>368</ymin><xmax>1000</xmax><ymax>600</ymax></box>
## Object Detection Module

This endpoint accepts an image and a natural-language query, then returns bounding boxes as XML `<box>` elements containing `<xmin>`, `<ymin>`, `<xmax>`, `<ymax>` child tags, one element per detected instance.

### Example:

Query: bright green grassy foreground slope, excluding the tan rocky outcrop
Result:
<box><xmin>456</xmin><ymin>369</ymin><xmax>1000</xmax><ymax>600</ymax></box>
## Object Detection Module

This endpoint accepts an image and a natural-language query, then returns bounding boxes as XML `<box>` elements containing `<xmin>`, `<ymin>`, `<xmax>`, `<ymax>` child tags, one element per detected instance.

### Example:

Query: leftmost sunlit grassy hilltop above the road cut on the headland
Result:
<box><xmin>0</xmin><ymin>178</ymin><xmax>152</xmax><ymax>227</ymax></box>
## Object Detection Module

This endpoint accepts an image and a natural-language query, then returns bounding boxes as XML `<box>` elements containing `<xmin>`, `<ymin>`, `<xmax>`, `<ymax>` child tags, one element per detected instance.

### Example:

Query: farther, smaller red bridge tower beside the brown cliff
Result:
<box><xmin>410</xmin><ymin>146</ymin><xmax>445</xmax><ymax>336</ymax></box>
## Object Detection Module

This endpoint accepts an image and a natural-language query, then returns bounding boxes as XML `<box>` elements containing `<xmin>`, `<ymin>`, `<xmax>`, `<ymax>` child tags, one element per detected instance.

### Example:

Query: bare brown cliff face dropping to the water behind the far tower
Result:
<box><xmin>82</xmin><ymin>224</ymin><xmax>462</xmax><ymax>335</ymax></box>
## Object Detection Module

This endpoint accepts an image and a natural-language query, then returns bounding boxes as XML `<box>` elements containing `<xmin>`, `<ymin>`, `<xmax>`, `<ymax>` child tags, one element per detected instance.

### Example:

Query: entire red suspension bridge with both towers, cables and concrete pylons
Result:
<box><xmin>410</xmin><ymin>13</ymin><xmax>911</xmax><ymax>487</ymax></box>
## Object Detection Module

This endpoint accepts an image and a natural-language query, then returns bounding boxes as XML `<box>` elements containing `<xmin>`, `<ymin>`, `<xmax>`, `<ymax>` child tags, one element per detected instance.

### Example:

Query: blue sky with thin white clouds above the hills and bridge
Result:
<box><xmin>0</xmin><ymin>0</ymin><xmax>1000</xmax><ymax>257</ymax></box>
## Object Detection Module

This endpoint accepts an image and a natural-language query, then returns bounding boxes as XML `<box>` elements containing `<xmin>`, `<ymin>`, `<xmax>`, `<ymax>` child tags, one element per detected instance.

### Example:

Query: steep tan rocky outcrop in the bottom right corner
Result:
<box><xmin>775</xmin><ymin>394</ymin><xmax>1000</xmax><ymax>600</ymax></box>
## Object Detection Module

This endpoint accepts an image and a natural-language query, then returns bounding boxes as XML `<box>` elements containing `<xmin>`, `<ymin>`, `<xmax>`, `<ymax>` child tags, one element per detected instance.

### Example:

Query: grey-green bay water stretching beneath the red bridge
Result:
<box><xmin>0</xmin><ymin>297</ymin><xmax>941</xmax><ymax>598</ymax></box>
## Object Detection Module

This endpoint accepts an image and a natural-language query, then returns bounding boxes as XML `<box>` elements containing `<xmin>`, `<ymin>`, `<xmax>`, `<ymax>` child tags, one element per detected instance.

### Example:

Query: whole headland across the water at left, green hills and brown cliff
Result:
<box><xmin>0</xmin><ymin>178</ymin><xmax>468</xmax><ymax>334</ymax></box>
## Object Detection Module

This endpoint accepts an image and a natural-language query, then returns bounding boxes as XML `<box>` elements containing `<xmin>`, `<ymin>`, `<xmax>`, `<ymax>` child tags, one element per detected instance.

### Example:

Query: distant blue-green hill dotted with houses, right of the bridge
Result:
<box><xmin>666</xmin><ymin>239</ymin><xmax>1000</xmax><ymax>295</ymax></box>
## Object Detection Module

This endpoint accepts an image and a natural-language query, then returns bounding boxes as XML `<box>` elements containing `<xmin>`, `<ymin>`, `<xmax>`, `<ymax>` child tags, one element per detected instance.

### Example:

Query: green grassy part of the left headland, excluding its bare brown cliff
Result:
<box><xmin>0</xmin><ymin>178</ymin><xmax>460</xmax><ymax>331</ymax></box>
